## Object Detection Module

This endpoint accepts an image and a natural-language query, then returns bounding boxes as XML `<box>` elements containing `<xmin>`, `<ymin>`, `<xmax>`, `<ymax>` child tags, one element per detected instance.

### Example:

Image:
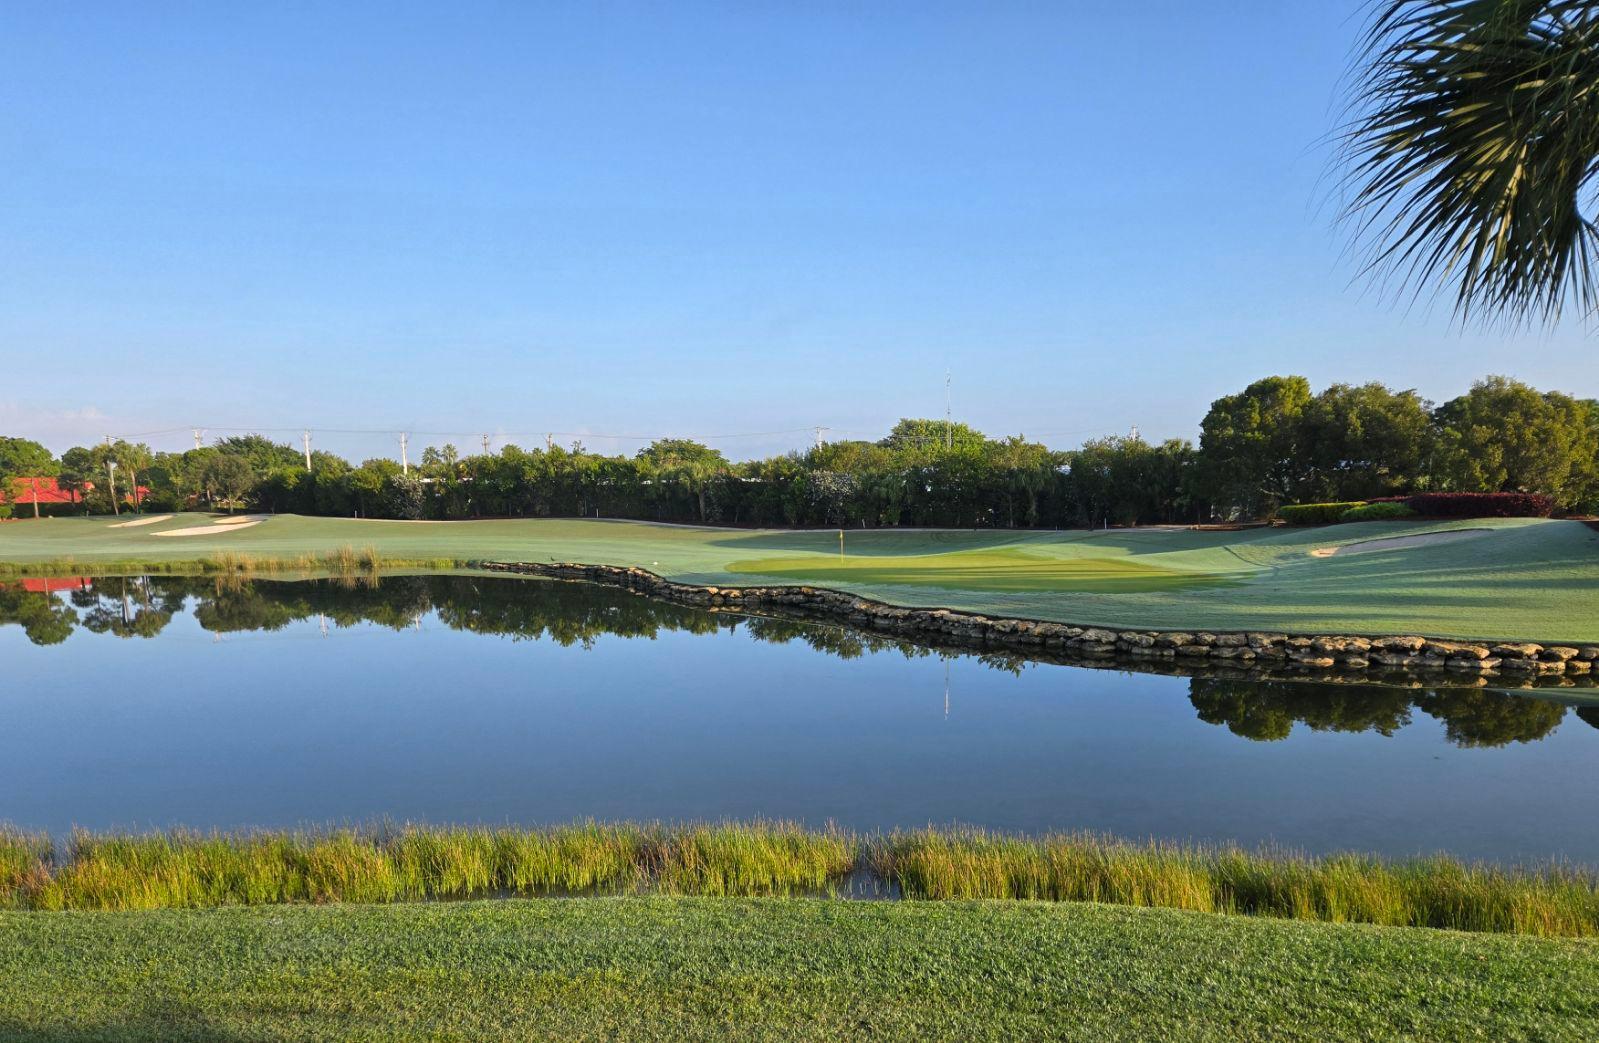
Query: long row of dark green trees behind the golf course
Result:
<box><xmin>0</xmin><ymin>376</ymin><xmax>1599</xmax><ymax>528</ymax></box>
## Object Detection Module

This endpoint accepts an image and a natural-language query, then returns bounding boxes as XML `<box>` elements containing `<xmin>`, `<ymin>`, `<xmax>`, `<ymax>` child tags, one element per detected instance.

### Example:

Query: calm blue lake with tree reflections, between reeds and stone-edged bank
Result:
<box><xmin>0</xmin><ymin>577</ymin><xmax>1599</xmax><ymax>864</ymax></box>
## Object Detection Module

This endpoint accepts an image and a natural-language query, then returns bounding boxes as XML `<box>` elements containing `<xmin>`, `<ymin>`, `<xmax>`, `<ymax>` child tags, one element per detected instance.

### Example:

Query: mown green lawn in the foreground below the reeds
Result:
<box><xmin>0</xmin><ymin>897</ymin><xmax>1599</xmax><ymax>1041</ymax></box>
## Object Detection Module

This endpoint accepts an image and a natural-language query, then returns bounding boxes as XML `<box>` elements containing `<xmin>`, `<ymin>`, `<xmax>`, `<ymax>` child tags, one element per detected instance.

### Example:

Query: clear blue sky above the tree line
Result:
<box><xmin>0</xmin><ymin>0</ymin><xmax>1599</xmax><ymax>458</ymax></box>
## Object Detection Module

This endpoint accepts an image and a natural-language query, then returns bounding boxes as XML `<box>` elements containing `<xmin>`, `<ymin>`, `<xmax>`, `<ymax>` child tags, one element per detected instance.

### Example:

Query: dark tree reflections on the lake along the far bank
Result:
<box><xmin>0</xmin><ymin>576</ymin><xmax>1599</xmax><ymax>747</ymax></box>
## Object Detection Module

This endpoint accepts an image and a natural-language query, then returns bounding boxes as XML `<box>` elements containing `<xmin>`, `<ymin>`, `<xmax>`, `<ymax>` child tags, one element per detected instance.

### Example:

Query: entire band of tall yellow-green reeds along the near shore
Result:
<box><xmin>0</xmin><ymin>822</ymin><xmax>1599</xmax><ymax>937</ymax></box>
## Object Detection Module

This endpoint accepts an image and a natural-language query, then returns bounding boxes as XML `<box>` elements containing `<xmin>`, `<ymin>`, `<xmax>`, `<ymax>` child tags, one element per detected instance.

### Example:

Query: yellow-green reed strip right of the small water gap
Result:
<box><xmin>871</xmin><ymin>830</ymin><xmax>1599</xmax><ymax>937</ymax></box>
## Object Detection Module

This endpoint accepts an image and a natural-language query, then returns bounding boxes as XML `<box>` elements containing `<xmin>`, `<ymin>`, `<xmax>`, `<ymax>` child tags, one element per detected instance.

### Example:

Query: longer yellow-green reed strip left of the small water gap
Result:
<box><xmin>12</xmin><ymin>822</ymin><xmax>860</xmax><ymax>910</ymax></box>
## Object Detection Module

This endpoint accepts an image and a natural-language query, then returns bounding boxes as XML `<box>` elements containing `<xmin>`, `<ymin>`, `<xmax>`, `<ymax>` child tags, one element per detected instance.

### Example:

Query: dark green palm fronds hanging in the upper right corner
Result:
<box><xmin>1342</xmin><ymin>0</ymin><xmax>1599</xmax><ymax>322</ymax></box>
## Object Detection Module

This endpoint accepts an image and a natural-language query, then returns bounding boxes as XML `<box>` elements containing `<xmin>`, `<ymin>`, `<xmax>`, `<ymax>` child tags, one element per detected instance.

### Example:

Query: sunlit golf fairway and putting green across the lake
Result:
<box><xmin>0</xmin><ymin>515</ymin><xmax>1599</xmax><ymax>643</ymax></box>
